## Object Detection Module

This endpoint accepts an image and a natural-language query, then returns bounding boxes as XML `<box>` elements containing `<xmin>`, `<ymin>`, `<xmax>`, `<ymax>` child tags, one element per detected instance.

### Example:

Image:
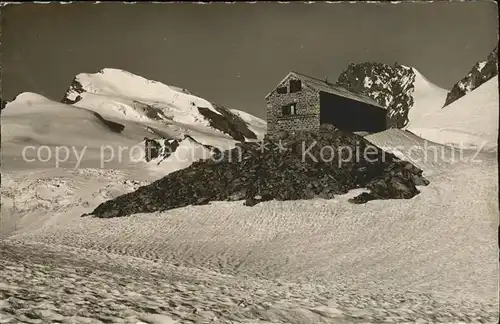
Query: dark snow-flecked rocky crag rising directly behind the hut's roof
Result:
<box><xmin>336</xmin><ymin>62</ymin><xmax>415</xmax><ymax>128</ymax></box>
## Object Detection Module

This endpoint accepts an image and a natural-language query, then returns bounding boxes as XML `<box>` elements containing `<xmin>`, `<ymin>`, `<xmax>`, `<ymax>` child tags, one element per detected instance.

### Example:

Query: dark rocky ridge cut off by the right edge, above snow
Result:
<box><xmin>443</xmin><ymin>47</ymin><xmax>498</xmax><ymax>107</ymax></box>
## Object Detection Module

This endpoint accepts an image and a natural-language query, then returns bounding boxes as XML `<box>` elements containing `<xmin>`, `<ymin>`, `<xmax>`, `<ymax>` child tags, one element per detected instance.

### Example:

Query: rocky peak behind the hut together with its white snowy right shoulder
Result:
<box><xmin>337</xmin><ymin>62</ymin><xmax>446</xmax><ymax>128</ymax></box>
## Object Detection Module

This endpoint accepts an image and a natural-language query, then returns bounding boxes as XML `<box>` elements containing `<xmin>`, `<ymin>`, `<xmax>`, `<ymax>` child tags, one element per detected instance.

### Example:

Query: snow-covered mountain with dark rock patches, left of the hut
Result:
<box><xmin>62</xmin><ymin>68</ymin><xmax>263</xmax><ymax>140</ymax></box>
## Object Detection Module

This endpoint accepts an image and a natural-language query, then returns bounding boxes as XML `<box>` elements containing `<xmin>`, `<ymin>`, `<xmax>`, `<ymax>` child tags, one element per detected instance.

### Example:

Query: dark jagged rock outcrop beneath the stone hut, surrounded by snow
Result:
<box><xmin>90</xmin><ymin>127</ymin><xmax>429</xmax><ymax>218</ymax></box>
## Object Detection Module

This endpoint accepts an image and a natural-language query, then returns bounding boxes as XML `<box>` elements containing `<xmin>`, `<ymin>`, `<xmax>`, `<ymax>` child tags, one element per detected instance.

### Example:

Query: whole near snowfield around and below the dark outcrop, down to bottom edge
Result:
<box><xmin>0</xmin><ymin>124</ymin><xmax>499</xmax><ymax>324</ymax></box>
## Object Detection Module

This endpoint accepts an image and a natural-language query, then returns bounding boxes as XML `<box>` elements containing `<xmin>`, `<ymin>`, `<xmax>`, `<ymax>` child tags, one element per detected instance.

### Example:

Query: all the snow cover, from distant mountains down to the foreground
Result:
<box><xmin>0</xmin><ymin>69</ymin><xmax>499</xmax><ymax>324</ymax></box>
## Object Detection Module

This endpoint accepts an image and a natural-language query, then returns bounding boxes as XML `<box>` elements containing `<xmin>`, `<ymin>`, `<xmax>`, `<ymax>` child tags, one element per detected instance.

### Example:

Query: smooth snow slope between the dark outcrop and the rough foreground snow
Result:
<box><xmin>2</xmin><ymin>155</ymin><xmax>498</xmax><ymax>307</ymax></box>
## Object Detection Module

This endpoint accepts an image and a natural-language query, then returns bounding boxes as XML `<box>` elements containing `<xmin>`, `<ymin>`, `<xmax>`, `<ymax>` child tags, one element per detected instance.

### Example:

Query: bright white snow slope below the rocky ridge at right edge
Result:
<box><xmin>408</xmin><ymin>76</ymin><xmax>499</xmax><ymax>150</ymax></box>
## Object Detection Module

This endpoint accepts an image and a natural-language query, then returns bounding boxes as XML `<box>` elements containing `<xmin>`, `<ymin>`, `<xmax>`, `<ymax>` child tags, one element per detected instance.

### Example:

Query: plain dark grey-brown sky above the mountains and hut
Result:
<box><xmin>0</xmin><ymin>0</ymin><xmax>498</xmax><ymax>117</ymax></box>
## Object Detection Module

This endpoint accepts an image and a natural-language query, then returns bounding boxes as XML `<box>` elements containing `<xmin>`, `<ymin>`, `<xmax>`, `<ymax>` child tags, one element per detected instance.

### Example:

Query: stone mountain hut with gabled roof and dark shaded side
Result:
<box><xmin>266</xmin><ymin>71</ymin><xmax>387</xmax><ymax>135</ymax></box>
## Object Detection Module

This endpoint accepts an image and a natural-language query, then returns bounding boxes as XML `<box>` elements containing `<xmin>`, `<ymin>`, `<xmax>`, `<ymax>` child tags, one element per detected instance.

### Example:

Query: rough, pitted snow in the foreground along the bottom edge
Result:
<box><xmin>6</xmin><ymin>241</ymin><xmax>498</xmax><ymax>324</ymax></box>
